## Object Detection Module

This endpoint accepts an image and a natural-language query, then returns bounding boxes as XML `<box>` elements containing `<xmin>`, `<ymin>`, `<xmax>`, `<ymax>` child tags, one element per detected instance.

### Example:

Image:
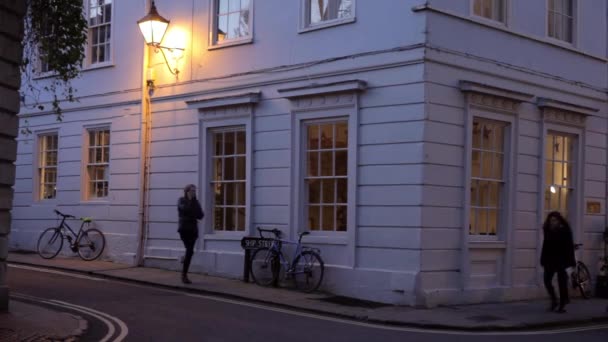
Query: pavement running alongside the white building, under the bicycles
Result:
<box><xmin>5</xmin><ymin>252</ymin><xmax>608</xmax><ymax>340</ymax></box>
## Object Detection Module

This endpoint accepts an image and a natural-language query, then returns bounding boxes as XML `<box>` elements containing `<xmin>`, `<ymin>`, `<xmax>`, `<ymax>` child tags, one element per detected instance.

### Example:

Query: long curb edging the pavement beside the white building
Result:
<box><xmin>7</xmin><ymin>260</ymin><xmax>608</xmax><ymax>333</ymax></box>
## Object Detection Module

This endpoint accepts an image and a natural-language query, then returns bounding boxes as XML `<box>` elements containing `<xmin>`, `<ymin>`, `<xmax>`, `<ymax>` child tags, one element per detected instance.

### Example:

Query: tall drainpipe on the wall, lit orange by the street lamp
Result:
<box><xmin>136</xmin><ymin>0</ymin><xmax>152</xmax><ymax>266</ymax></box>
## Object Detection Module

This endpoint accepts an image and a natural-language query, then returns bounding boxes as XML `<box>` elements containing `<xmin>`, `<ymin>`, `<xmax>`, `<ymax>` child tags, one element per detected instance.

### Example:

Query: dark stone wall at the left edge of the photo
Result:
<box><xmin>0</xmin><ymin>0</ymin><xmax>25</xmax><ymax>312</ymax></box>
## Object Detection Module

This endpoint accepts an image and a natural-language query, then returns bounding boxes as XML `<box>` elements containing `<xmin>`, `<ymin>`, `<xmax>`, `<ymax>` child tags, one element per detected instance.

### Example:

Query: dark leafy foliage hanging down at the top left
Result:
<box><xmin>21</xmin><ymin>0</ymin><xmax>87</xmax><ymax>120</ymax></box>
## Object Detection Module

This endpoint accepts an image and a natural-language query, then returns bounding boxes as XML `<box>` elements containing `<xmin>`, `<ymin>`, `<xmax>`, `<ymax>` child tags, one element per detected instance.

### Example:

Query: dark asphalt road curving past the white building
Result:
<box><xmin>8</xmin><ymin>267</ymin><xmax>608</xmax><ymax>342</ymax></box>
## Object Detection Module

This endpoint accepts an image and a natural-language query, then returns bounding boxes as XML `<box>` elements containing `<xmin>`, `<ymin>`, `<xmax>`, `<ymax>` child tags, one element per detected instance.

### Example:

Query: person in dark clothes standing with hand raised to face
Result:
<box><xmin>177</xmin><ymin>184</ymin><xmax>205</xmax><ymax>284</ymax></box>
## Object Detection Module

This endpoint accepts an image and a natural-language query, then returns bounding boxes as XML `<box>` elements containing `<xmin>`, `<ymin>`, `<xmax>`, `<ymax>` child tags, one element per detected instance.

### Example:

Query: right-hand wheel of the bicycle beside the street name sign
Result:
<box><xmin>293</xmin><ymin>251</ymin><xmax>325</xmax><ymax>292</ymax></box>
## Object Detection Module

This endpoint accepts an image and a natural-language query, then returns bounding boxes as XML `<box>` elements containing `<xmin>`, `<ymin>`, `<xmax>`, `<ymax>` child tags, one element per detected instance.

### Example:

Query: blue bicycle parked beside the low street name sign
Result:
<box><xmin>250</xmin><ymin>227</ymin><xmax>325</xmax><ymax>292</ymax></box>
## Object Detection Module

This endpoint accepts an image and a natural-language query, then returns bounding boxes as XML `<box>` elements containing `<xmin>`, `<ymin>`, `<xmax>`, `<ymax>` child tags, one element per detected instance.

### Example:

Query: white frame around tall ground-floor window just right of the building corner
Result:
<box><xmin>464</xmin><ymin>111</ymin><xmax>516</xmax><ymax>244</ymax></box>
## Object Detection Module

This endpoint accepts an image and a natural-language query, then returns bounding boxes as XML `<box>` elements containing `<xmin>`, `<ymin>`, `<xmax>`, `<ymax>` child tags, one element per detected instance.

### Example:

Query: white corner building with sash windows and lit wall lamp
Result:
<box><xmin>10</xmin><ymin>0</ymin><xmax>608</xmax><ymax>307</ymax></box>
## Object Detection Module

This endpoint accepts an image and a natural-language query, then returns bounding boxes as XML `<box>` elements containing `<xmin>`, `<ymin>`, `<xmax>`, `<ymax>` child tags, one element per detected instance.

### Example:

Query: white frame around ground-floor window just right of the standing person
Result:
<box><xmin>199</xmin><ymin>115</ymin><xmax>253</xmax><ymax>236</ymax></box>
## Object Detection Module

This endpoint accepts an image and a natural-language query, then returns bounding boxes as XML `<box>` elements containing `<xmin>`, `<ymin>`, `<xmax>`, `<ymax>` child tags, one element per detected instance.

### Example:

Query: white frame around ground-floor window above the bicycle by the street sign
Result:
<box><xmin>292</xmin><ymin>107</ymin><xmax>358</xmax><ymax>245</ymax></box>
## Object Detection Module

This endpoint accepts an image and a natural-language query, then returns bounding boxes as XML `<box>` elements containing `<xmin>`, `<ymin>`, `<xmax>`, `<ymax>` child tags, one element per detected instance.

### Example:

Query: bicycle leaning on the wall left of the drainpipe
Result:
<box><xmin>37</xmin><ymin>209</ymin><xmax>106</xmax><ymax>261</ymax></box>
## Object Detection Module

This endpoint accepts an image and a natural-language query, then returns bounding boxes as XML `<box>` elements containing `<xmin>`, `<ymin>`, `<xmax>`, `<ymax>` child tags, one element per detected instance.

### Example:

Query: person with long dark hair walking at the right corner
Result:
<box><xmin>540</xmin><ymin>211</ymin><xmax>576</xmax><ymax>313</ymax></box>
